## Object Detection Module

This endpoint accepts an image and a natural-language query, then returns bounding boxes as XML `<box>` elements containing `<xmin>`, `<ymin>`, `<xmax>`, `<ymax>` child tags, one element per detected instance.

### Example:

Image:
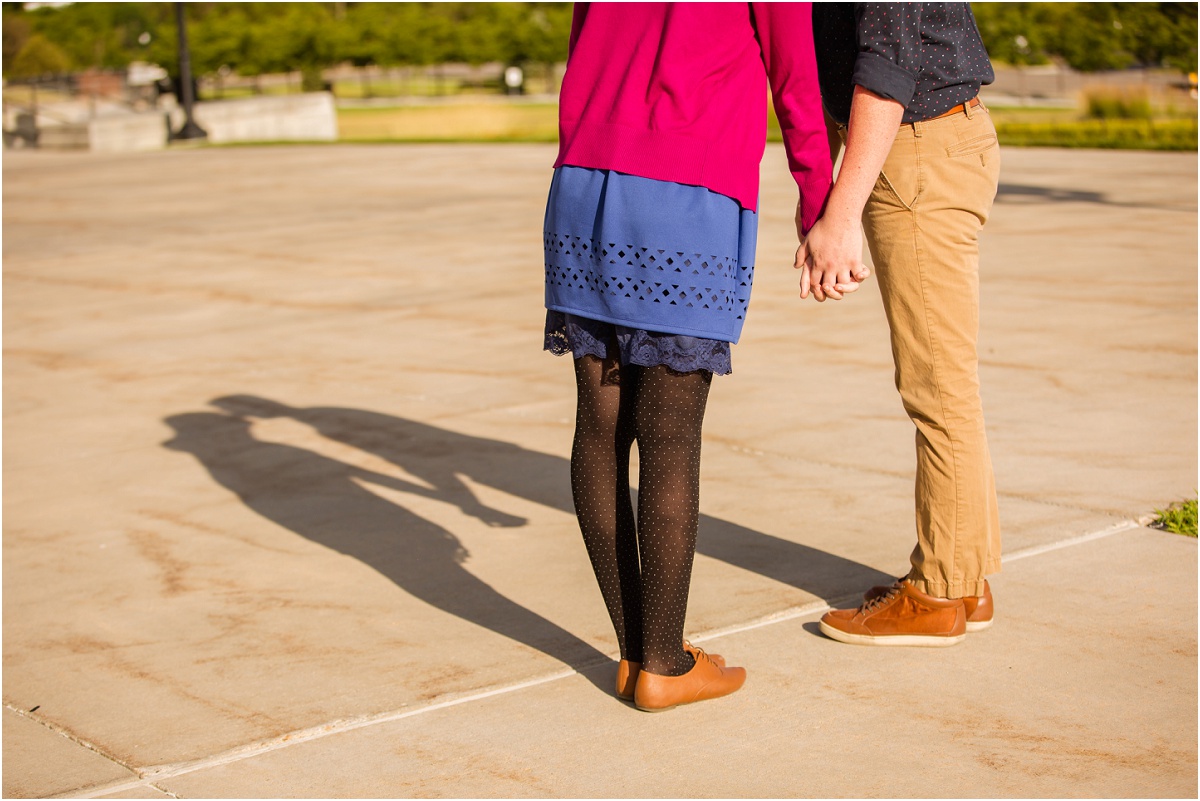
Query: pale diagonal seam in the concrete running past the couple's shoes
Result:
<box><xmin>60</xmin><ymin>516</ymin><xmax>1153</xmax><ymax>799</ymax></box>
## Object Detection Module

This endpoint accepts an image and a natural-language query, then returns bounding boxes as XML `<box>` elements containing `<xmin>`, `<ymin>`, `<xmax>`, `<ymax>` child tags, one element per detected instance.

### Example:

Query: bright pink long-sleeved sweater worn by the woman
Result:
<box><xmin>554</xmin><ymin>2</ymin><xmax>832</xmax><ymax>233</ymax></box>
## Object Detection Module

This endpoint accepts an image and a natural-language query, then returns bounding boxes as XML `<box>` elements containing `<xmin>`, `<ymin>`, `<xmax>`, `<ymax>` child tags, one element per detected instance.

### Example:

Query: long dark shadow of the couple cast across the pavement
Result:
<box><xmin>164</xmin><ymin>396</ymin><xmax>894</xmax><ymax>681</ymax></box>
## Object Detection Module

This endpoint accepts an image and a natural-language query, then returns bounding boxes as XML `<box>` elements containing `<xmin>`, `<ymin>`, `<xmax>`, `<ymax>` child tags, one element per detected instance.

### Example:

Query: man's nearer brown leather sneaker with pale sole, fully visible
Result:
<box><xmin>821</xmin><ymin>580</ymin><xmax>967</xmax><ymax>646</ymax></box>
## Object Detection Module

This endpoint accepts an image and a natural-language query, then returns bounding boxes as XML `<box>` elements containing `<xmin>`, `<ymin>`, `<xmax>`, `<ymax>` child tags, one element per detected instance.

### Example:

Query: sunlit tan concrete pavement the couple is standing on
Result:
<box><xmin>4</xmin><ymin>145</ymin><xmax>1196</xmax><ymax>797</ymax></box>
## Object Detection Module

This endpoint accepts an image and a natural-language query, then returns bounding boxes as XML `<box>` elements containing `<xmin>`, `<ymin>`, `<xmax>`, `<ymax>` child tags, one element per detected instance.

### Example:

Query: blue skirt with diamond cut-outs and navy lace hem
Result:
<box><xmin>544</xmin><ymin>167</ymin><xmax>758</xmax><ymax>373</ymax></box>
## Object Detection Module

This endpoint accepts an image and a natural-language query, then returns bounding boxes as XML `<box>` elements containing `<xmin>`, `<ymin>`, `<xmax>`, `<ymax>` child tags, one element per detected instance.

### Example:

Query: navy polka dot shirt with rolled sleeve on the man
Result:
<box><xmin>812</xmin><ymin>2</ymin><xmax>995</xmax><ymax>124</ymax></box>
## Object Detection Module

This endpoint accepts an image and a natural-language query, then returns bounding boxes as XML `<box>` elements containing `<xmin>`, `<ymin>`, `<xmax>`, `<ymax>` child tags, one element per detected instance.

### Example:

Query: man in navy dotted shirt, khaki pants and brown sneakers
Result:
<box><xmin>796</xmin><ymin>2</ymin><xmax>1000</xmax><ymax>645</ymax></box>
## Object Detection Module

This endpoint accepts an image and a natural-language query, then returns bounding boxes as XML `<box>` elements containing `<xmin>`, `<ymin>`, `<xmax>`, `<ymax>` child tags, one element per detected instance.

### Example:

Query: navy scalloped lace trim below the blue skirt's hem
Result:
<box><xmin>544</xmin><ymin>309</ymin><xmax>733</xmax><ymax>375</ymax></box>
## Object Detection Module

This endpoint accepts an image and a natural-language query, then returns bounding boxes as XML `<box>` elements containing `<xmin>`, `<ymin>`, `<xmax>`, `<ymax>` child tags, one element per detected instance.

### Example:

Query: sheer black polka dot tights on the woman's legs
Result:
<box><xmin>571</xmin><ymin>356</ymin><xmax>712</xmax><ymax>676</ymax></box>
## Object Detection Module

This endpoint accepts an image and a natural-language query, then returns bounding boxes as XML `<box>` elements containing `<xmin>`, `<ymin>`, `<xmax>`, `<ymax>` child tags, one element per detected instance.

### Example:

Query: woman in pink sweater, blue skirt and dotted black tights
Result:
<box><xmin>545</xmin><ymin>4</ymin><xmax>830</xmax><ymax>711</ymax></box>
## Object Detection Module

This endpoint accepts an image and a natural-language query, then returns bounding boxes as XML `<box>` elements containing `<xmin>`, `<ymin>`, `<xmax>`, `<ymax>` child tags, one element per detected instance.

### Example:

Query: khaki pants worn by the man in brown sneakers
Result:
<box><xmin>863</xmin><ymin>106</ymin><xmax>1000</xmax><ymax>598</ymax></box>
